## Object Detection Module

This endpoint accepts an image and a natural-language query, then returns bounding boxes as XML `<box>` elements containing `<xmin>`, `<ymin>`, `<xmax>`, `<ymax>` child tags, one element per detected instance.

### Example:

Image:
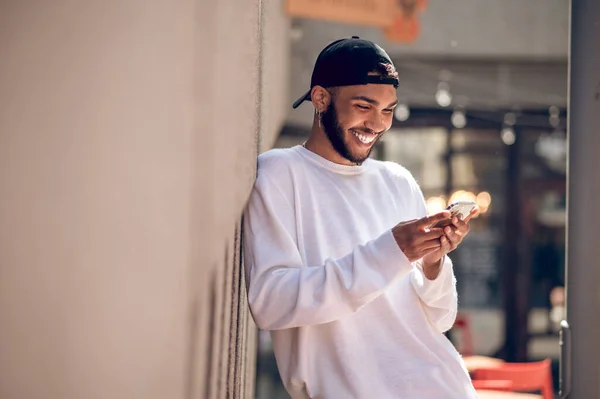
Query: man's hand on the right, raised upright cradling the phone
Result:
<box><xmin>423</xmin><ymin>208</ymin><xmax>479</xmax><ymax>280</ymax></box>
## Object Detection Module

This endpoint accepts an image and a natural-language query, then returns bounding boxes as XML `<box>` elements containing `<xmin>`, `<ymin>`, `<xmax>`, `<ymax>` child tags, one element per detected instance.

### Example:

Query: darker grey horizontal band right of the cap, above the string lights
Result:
<box><xmin>394</xmin><ymin>58</ymin><xmax>567</xmax><ymax>109</ymax></box>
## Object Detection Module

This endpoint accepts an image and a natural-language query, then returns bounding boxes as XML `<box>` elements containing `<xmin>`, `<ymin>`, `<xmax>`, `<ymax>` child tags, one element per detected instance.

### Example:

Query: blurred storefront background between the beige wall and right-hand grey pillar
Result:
<box><xmin>257</xmin><ymin>0</ymin><xmax>569</xmax><ymax>399</ymax></box>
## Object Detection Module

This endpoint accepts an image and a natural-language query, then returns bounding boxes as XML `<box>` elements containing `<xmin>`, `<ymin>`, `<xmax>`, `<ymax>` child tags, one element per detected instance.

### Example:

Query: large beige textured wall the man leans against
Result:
<box><xmin>0</xmin><ymin>0</ymin><xmax>288</xmax><ymax>399</ymax></box>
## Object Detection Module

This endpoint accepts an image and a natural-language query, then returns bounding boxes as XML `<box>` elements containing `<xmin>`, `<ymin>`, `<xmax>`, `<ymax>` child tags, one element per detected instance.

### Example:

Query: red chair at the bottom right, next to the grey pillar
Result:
<box><xmin>473</xmin><ymin>359</ymin><xmax>554</xmax><ymax>399</ymax></box>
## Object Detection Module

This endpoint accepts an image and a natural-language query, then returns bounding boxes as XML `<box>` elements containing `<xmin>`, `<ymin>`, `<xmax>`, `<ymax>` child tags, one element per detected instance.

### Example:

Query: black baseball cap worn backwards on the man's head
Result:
<box><xmin>292</xmin><ymin>36</ymin><xmax>399</xmax><ymax>108</ymax></box>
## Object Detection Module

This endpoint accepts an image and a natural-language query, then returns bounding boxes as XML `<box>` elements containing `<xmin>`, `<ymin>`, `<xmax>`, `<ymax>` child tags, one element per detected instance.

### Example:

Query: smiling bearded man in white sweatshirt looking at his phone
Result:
<box><xmin>244</xmin><ymin>37</ymin><xmax>477</xmax><ymax>399</ymax></box>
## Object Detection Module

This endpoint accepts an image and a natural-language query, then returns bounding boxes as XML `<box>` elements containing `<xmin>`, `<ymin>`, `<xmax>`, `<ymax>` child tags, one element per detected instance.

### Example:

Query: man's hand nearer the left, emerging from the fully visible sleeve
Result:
<box><xmin>392</xmin><ymin>211</ymin><xmax>450</xmax><ymax>262</ymax></box>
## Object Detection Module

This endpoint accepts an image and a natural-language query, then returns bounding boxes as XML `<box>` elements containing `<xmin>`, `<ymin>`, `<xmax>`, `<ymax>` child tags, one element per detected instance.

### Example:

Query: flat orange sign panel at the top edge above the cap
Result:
<box><xmin>287</xmin><ymin>0</ymin><xmax>398</xmax><ymax>28</ymax></box>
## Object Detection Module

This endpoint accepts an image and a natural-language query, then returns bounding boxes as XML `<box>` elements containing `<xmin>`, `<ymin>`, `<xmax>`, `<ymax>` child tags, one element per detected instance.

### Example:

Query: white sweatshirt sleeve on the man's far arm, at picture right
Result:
<box><xmin>410</xmin><ymin>176</ymin><xmax>458</xmax><ymax>332</ymax></box>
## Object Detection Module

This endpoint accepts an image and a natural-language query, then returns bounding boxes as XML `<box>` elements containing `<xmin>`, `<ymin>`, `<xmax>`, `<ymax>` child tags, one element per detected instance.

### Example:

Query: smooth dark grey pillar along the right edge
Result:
<box><xmin>567</xmin><ymin>0</ymin><xmax>600</xmax><ymax>399</ymax></box>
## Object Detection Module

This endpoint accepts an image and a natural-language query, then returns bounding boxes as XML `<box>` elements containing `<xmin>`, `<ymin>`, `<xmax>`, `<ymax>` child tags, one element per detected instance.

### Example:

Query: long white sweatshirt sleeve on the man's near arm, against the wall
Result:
<box><xmin>244</xmin><ymin>173</ymin><xmax>413</xmax><ymax>330</ymax></box>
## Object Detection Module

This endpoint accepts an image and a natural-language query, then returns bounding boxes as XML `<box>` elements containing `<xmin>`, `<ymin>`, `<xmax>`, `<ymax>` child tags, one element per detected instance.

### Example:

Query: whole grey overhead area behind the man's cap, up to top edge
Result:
<box><xmin>288</xmin><ymin>4</ymin><xmax>568</xmax><ymax>130</ymax></box>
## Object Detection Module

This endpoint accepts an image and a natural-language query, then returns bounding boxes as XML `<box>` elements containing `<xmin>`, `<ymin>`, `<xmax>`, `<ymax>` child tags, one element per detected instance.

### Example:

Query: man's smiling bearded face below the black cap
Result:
<box><xmin>321</xmin><ymin>84</ymin><xmax>397</xmax><ymax>164</ymax></box>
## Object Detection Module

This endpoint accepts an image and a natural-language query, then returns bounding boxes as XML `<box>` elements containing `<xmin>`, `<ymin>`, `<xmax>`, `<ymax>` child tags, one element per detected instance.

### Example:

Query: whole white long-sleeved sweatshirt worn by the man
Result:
<box><xmin>244</xmin><ymin>146</ymin><xmax>477</xmax><ymax>399</ymax></box>
